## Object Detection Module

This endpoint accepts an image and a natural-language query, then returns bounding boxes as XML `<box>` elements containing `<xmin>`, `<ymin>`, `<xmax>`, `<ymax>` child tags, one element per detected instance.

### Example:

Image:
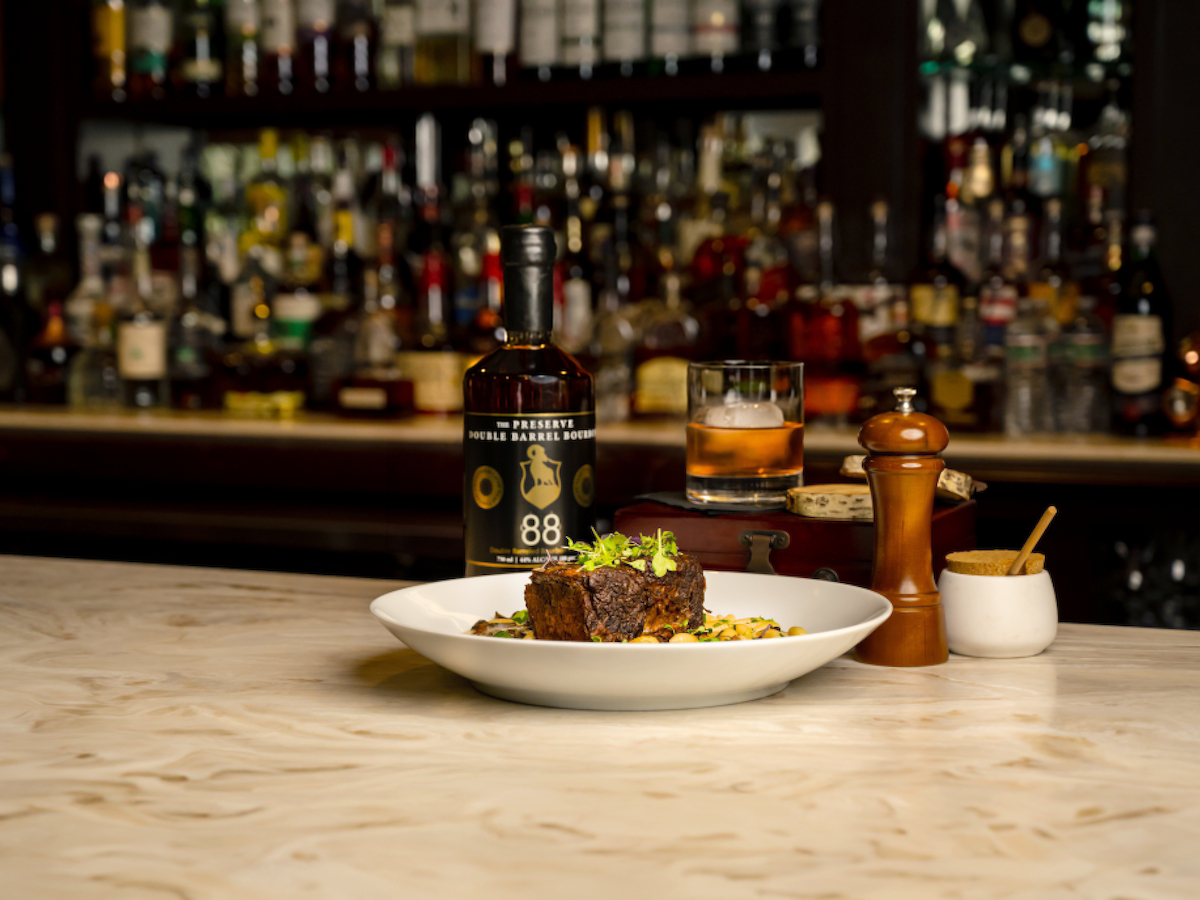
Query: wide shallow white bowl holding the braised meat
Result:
<box><xmin>371</xmin><ymin>572</ymin><xmax>892</xmax><ymax>709</ymax></box>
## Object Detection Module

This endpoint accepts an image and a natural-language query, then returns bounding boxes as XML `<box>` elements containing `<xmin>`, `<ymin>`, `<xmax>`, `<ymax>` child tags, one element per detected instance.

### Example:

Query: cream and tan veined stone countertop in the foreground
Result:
<box><xmin>0</xmin><ymin>557</ymin><xmax>1200</xmax><ymax>900</ymax></box>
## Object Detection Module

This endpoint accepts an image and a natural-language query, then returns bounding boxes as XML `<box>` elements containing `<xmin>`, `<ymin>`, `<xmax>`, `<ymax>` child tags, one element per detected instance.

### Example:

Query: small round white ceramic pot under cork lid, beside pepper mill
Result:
<box><xmin>937</xmin><ymin>569</ymin><xmax>1058</xmax><ymax>659</ymax></box>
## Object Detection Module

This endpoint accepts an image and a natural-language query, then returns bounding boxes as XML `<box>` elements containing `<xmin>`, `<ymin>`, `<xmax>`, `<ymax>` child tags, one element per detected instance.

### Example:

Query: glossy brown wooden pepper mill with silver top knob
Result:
<box><xmin>857</xmin><ymin>388</ymin><xmax>950</xmax><ymax>666</ymax></box>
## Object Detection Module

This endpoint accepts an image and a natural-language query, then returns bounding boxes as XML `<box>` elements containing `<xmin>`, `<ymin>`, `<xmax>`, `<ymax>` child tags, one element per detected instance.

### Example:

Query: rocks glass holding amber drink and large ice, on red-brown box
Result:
<box><xmin>688</xmin><ymin>360</ymin><xmax>804</xmax><ymax>509</ymax></box>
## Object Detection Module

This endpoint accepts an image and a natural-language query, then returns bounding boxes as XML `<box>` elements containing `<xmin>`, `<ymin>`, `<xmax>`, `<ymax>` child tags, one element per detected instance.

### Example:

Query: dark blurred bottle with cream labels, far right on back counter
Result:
<box><xmin>1112</xmin><ymin>215</ymin><xmax>1172</xmax><ymax>436</ymax></box>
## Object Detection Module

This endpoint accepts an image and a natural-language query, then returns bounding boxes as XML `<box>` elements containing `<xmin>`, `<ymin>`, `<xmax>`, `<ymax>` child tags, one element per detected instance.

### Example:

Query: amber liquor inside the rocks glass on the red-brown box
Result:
<box><xmin>688</xmin><ymin>422</ymin><xmax>804</xmax><ymax>506</ymax></box>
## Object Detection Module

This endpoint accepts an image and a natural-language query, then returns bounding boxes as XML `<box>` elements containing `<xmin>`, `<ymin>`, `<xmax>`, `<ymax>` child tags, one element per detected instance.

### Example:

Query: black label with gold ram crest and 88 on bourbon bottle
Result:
<box><xmin>463</xmin><ymin>413</ymin><xmax>596</xmax><ymax>575</ymax></box>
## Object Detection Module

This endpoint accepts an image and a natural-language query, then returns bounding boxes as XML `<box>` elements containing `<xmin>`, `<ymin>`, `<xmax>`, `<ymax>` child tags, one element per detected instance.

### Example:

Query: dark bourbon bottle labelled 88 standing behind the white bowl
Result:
<box><xmin>463</xmin><ymin>226</ymin><xmax>595</xmax><ymax>576</ymax></box>
